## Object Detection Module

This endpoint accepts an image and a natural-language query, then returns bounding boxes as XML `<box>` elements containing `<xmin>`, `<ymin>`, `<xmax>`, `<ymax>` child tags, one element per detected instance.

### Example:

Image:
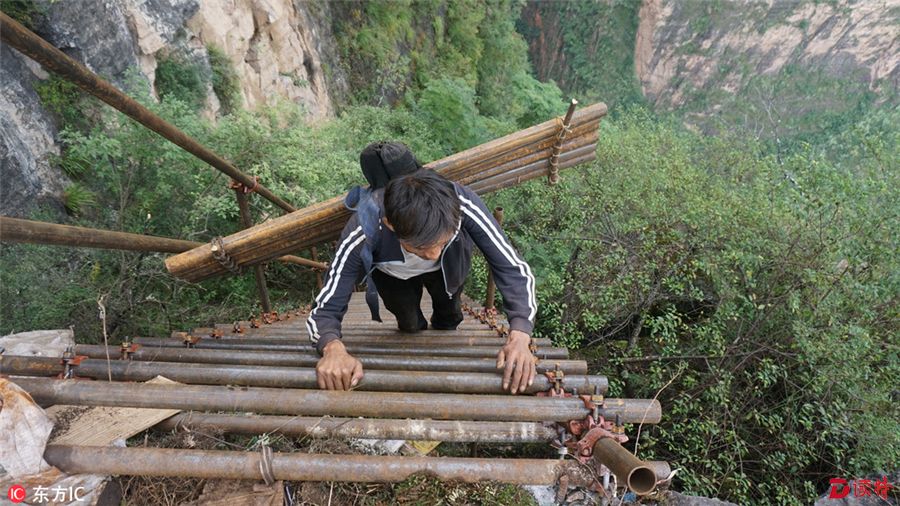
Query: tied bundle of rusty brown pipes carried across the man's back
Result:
<box><xmin>166</xmin><ymin>101</ymin><xmax>606</xmax><ymax>281</ymax></box>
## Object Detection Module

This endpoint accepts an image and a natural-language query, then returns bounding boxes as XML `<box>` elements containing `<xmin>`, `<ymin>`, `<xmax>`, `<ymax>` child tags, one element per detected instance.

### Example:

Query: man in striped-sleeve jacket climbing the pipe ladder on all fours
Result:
<box><xmin>307</xmin><ymin>142</ymin><xmax>537</xmax><ymax>393</ymax></box>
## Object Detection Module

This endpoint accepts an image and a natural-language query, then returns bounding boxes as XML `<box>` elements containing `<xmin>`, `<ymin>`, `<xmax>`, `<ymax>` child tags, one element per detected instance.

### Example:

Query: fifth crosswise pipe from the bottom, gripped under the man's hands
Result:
<box><xmin>75</xmin><ymin>344</ymin><xmax>587</xmax><ymax>374</ymax></box>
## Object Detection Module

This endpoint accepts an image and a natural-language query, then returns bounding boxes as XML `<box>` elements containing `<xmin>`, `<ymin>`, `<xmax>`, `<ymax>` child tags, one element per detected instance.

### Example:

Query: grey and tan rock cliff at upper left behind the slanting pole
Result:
<box><xmin>0</xmin><ymin>0</ymin><xmax>345</xmax><ymax>216</ymax></box>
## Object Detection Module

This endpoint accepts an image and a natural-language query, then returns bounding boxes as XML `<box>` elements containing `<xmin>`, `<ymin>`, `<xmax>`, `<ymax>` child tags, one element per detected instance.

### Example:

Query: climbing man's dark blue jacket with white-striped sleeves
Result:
<box><xmin>306</xmin><ymin>183</ymin><xmax>537</xmax><ymax>354</ymax></box>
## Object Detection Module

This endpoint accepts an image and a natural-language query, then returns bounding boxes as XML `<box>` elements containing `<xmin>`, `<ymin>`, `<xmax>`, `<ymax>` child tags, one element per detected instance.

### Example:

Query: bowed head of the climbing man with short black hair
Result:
<box><xmin>384</xmin><ymin>170</ymin><xmax>460</xmax><ymax>260</ymax></box>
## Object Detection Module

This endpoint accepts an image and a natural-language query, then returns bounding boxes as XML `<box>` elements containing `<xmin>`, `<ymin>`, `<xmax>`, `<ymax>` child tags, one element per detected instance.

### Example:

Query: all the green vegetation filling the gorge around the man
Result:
<box><xmin>0</xmin><ymin>1</ymin><xmax>900</xmax><ymax>504</ymax></box>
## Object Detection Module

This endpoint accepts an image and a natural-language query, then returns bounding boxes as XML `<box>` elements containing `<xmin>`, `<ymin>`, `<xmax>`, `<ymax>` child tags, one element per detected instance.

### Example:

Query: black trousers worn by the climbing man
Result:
<box><xmin>372</xmin><ymin>269</ymin><xmax>463</xmax><ymax>332</ymax></box>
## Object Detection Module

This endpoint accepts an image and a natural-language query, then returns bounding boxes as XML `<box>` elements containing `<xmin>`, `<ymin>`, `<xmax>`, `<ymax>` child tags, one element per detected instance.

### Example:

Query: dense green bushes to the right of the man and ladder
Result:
<box><xmin>486</xmin><ymin>109</ymin><xmax>900</xmax><ymax>504</ymax></box>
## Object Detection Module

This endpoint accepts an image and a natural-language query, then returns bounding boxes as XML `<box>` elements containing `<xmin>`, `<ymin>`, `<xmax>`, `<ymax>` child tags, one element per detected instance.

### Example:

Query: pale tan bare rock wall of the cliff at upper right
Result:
<box><xmin>635</xmin><ymin>0</ymin><xmax>900</xmax><ymax>109</ymax></box>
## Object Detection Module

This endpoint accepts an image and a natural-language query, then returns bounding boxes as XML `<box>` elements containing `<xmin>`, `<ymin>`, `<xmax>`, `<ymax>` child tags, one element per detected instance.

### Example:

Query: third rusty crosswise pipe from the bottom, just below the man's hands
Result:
<box><xmin>12</xmin><ymin>377</ymin><xmax>661</xmax><ymax>423</ymax></box>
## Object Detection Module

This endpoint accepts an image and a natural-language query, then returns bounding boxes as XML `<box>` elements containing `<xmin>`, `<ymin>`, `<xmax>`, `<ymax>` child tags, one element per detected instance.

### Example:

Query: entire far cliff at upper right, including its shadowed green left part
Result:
<box><xmin>520</xmin><ymin>0</ymin><xmax>900</xmax><ymax>138</ymax></box>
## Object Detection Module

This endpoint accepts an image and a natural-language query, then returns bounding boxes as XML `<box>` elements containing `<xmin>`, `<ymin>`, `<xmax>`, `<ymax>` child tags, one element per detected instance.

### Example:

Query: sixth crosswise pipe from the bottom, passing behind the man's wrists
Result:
<box><xmin>133</xmin><ymin>337</ymin><xmax>569</xmax><ymax>359</ymax></box>
